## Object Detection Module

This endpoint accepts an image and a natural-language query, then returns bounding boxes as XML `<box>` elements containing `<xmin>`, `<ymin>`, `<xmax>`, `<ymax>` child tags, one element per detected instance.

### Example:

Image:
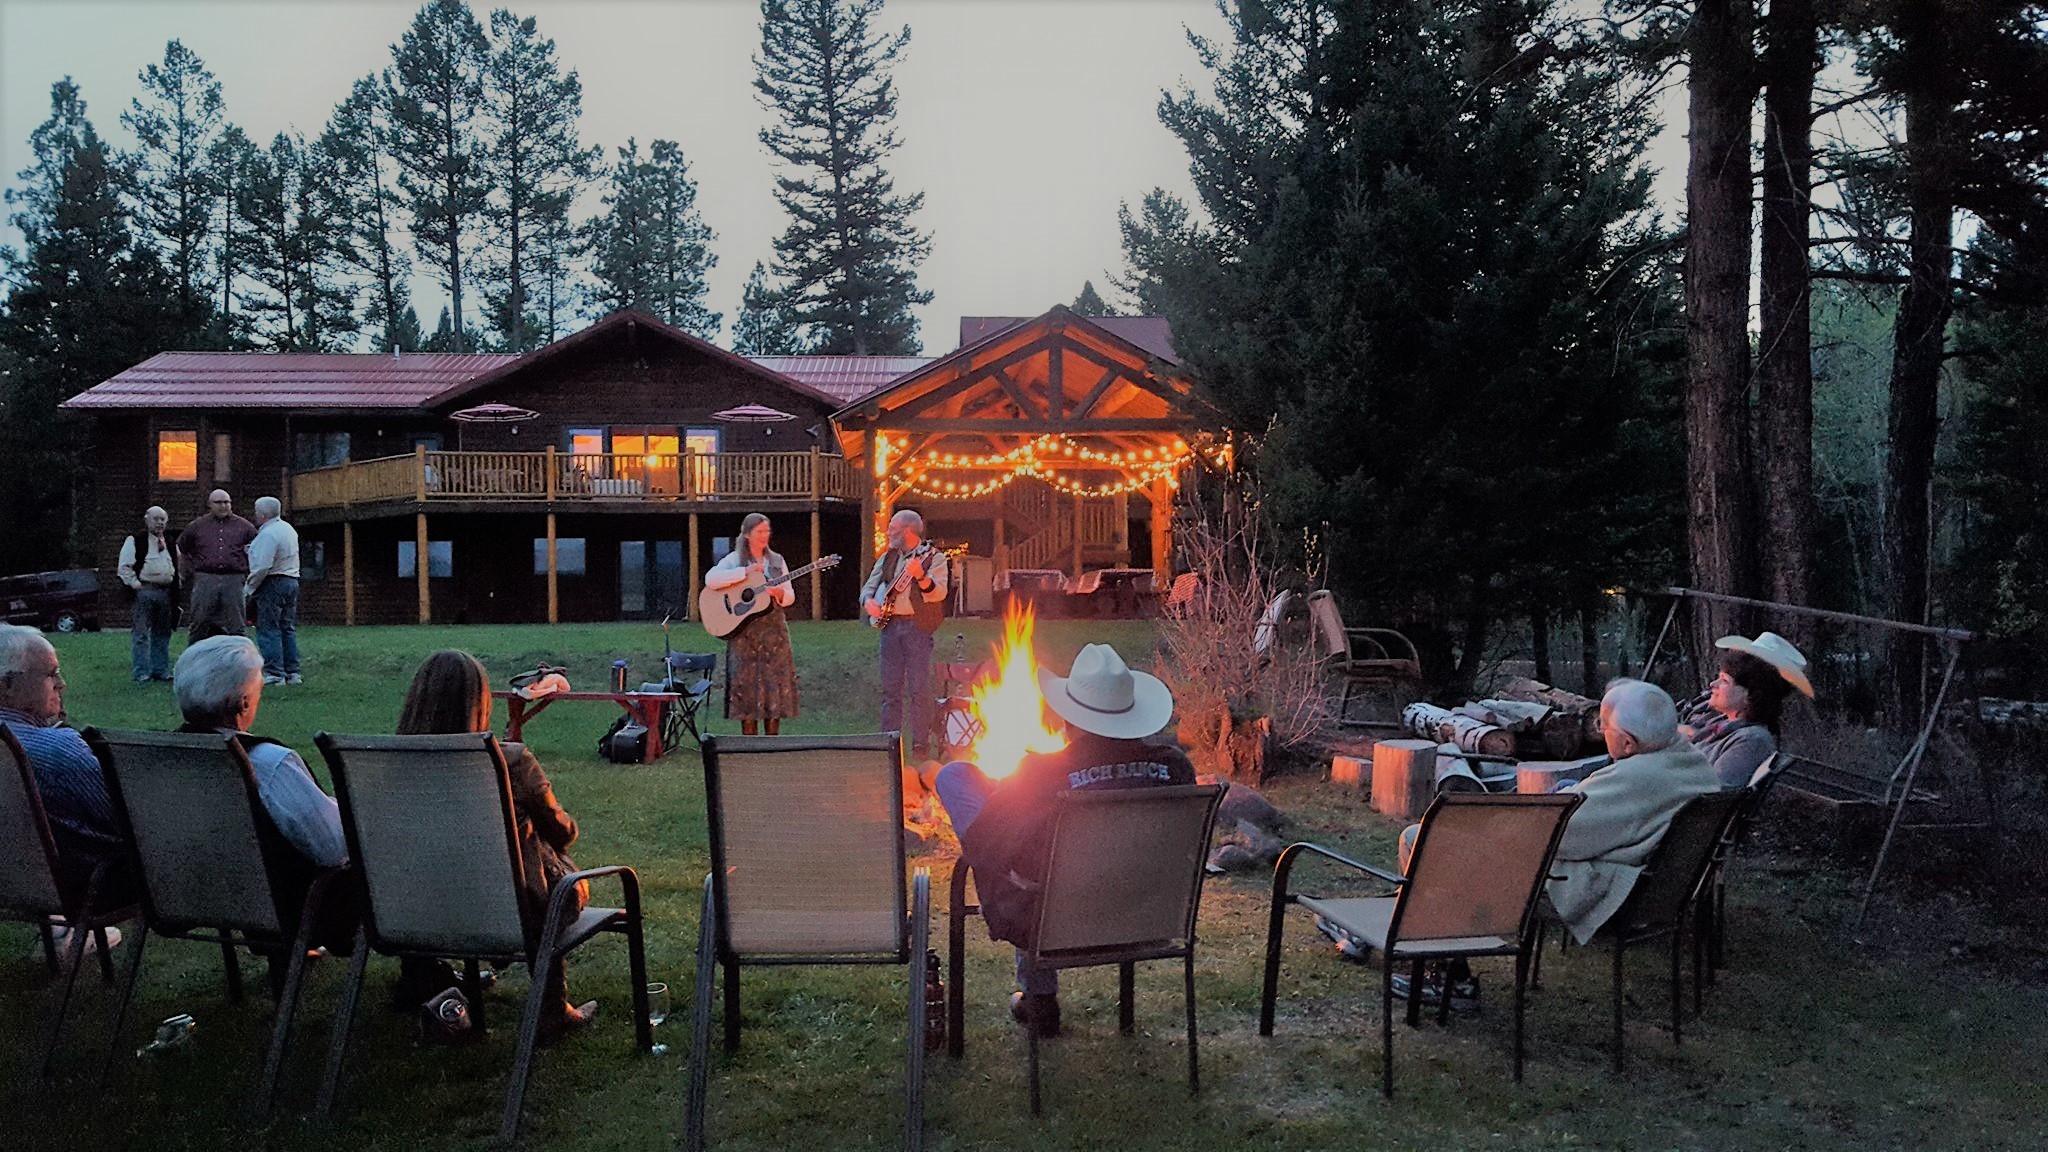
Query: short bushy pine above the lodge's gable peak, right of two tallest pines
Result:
<box><xmin>588</xmin><ymin>139</ymin><xmax>721</xmax><ymax>340</ymax></box>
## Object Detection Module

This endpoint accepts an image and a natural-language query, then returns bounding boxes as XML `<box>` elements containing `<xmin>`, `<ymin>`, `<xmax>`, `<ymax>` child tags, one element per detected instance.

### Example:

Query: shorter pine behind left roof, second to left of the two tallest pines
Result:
<box><xmin>236</xmin><ymin>133</ymin><xmax>358</xmax><ymax>353</ymax></box>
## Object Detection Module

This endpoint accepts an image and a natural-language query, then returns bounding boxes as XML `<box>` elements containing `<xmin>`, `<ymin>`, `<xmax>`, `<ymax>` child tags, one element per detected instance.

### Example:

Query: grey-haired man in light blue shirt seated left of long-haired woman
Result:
<box><xmin>172</xmin><ymin>635</ymin><xmax>356</xmax><ymax>988</ymax></box>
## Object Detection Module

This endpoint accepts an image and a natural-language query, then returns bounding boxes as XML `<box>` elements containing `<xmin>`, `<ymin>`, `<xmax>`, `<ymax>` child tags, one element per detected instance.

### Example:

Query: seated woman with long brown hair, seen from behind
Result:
<box><xmin>397</xmin><ymin>650</ymin><xmax>598</xmax><ymax>1035</ymax></box>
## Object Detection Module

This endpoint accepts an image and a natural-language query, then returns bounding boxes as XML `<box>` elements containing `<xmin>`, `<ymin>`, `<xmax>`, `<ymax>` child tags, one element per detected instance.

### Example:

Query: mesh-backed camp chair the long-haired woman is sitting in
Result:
<box><xmin>313</xmin><ymin>732</ymin><xmax>653</xmax><ymax>1142</ymax></box>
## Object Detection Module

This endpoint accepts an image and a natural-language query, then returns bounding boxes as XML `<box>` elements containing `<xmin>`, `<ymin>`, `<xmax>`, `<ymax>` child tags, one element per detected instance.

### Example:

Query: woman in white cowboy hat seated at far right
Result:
<box><xmin>1679</xmin><ymin>631</ymin><xmax>1812</xmax><ymax>789</ymax></box>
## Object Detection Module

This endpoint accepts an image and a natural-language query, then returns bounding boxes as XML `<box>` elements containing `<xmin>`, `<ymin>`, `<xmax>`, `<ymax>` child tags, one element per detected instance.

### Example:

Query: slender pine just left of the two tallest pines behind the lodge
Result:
<box><xmin>319</xmin><ymin>76</ymin><xmax>420</xmax><ymax>353</ymax></box>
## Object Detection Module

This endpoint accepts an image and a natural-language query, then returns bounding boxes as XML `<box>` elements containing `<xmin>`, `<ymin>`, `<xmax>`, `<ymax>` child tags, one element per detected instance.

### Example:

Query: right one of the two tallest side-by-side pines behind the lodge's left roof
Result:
<box><xmin>479</xmin><ymin>8</ymin><xmax>604</xmax><ymax>353</ymax></box>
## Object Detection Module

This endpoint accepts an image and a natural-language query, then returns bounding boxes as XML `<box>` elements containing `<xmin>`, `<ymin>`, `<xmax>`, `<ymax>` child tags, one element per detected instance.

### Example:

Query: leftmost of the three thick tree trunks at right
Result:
<box><xmin>1686</xmin><ymin>0</ymin><xmax>1755</xmax><ymax>648</ymax></box>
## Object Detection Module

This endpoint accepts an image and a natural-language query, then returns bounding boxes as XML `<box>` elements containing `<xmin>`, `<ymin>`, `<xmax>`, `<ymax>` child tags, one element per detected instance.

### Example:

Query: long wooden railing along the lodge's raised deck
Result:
<box><xmin>291</xmin><ymin>449</ymin><xmax>860</xmax><ymax>508</ymax></box>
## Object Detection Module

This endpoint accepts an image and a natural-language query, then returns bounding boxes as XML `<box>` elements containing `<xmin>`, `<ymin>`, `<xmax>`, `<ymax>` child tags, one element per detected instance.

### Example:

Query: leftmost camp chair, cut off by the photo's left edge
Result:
<box><xmin>0</xmin><ymin>724</ymin><xmax>141</xmax><ymax>1076</ymax></box>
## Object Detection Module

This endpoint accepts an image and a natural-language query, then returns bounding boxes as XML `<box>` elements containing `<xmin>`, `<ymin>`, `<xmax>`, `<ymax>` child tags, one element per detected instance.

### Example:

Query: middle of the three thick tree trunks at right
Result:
<box><xmin>1757</xmin><ymin>0</ymin><xmax>1819</xmax><ymax>619</ymax></box>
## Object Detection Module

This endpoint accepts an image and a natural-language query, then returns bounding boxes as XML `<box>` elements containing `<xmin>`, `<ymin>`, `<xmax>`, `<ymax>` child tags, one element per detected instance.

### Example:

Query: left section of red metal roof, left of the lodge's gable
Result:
<box><xmin>63</xmin><ymin>353</ymin><xmax>518</xmax><ymax>410</ymax></box>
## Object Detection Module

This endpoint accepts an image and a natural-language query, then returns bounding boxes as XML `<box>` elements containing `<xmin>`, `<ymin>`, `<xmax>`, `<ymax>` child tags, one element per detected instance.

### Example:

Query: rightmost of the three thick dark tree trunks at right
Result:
<box><xmin>1884</xmin><ymin>0</ymin><xmax>1956</xmax><ymax>703</ymax></box>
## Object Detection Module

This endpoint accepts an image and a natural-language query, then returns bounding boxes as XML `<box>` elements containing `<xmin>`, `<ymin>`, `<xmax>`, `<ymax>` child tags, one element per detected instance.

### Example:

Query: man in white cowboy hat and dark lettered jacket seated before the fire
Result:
<box><xmin>934</xmin><ymin>644</ymin><xmax>1194</xmax><ymax>1035</ymax></box>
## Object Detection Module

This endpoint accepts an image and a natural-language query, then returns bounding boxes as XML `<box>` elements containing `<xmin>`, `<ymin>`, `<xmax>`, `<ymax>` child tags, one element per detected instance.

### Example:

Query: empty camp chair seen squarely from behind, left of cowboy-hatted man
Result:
<box><xmin>684</xmin><ymin>732</ymin><xmax>932</xmax><ymax>1152</ymax></box>
